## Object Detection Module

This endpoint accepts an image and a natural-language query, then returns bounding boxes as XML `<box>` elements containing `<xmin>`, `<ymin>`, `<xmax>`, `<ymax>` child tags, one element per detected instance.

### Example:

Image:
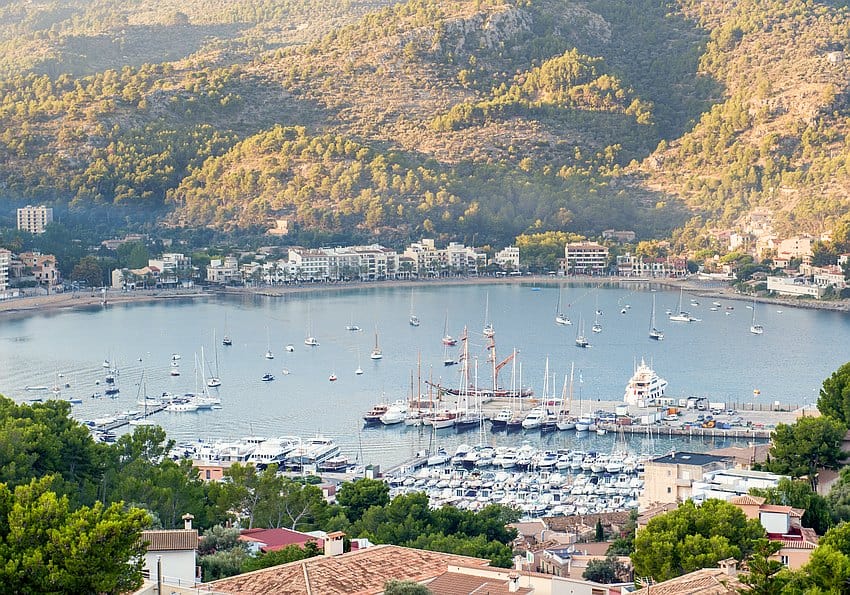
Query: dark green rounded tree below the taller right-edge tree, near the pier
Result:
<box><xmin>765</xmin><ymin>416</ymin><xmax>847</xmax><ymax>488</ymax></box>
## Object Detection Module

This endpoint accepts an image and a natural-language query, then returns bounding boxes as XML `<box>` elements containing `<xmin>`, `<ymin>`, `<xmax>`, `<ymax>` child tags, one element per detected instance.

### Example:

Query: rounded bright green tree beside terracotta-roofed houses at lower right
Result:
<box><xmin>632</xmin><ymin>499</ymin><xmax>765</xmax><ymax>581</ymax></box>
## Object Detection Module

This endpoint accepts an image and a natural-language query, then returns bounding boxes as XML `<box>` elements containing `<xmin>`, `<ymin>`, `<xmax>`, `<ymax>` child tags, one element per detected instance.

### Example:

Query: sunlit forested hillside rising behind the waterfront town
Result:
<box><xmin>0</xmin><ymin>0</ymin><xmax>848</xmax><ymax>243</ymax></box>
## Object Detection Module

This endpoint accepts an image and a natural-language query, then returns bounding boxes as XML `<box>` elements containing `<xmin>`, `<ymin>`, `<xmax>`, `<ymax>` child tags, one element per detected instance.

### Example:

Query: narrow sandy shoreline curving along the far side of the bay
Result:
<box><xmin>0</xmin><ymin>276</ymin><xmax>850</xmax><ymax>316</ymax></box>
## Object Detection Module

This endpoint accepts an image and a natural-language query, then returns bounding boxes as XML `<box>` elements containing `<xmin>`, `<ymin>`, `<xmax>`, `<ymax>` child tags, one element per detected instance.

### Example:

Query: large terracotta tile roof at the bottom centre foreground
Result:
<box><xmin>206</xmin><ymin>545</ymin><xmax>490</xmax><ymax>595</ymax></box>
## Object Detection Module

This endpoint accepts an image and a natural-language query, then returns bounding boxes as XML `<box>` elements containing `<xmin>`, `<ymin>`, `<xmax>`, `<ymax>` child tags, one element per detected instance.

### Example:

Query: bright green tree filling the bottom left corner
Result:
<box><xmin>0</xmin><ymin>476</ymin><xmax>149</xmax><ymax>594</ymax></box>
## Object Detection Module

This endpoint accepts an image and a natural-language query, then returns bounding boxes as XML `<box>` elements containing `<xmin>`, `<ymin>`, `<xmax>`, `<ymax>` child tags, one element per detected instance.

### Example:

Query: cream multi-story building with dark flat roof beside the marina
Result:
<box><xmin>640</xmin><ymin>452</ymin><xmax>732</xmax><ymax>509</ymax></box>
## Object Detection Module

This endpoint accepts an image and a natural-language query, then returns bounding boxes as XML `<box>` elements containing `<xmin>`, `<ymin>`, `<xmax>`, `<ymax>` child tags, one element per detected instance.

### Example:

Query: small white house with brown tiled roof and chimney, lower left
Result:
<box><xmin>142</xmin><ymin>514</ymin><xmax>199</xmax><ymax>587</ymax></box>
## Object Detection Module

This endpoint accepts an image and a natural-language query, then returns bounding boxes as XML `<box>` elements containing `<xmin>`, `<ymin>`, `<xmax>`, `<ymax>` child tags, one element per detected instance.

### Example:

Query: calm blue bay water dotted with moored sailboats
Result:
<box><xmin>0</xmin><ymin>284</ymin><xmax>850</xmax><ymax>465</ymax></box>
